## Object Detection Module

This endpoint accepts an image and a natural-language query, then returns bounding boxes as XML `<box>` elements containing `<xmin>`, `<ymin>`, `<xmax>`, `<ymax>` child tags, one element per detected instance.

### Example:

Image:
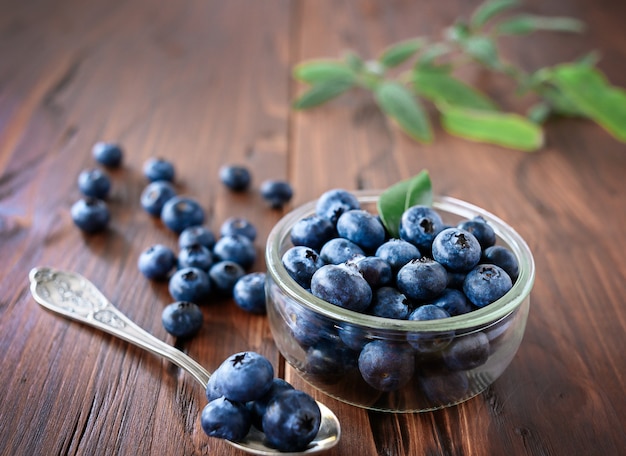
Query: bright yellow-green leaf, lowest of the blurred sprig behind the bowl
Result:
<box><xmin>437</xmin><ymin>105</ymin><xmax>543</xmax><ymax>151</ymax></box>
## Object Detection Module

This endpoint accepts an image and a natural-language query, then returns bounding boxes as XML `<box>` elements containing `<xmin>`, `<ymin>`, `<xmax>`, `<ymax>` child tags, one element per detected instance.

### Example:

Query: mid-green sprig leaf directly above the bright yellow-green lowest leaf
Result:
<box><xmin>413</xmin><ymin>66</ymin><xmax>497</xmax><ymax>110</ymax></box>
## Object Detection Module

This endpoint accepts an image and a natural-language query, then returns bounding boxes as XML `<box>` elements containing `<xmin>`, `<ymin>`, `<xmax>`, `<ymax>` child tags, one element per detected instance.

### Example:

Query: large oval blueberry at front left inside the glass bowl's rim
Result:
<box><xmin>311</xmin><ymin>264</ymin><xmax>372</xmax><ymax>312</ymax></box>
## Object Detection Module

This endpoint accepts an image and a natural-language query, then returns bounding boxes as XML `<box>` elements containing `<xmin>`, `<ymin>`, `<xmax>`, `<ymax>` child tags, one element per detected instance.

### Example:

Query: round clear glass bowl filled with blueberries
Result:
<box><xmin>265</xmin><ymin>182</ymin><xmax>535</xmax><ymax>412</ymax></box>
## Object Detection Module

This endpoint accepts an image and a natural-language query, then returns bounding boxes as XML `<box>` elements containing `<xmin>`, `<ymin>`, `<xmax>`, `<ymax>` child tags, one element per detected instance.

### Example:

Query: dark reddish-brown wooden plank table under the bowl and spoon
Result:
<box><xmin>0</xmin><ymin>0</ymin><xmax>626</xmax><ymax>456</ymax></box>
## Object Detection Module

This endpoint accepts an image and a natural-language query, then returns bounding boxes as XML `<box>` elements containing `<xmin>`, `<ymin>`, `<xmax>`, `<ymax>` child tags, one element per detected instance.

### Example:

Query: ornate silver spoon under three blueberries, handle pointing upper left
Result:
<box><xmin>29</xmin><ymin>267</ymin><xmax>341</xmax><ymax>456</ymax></box>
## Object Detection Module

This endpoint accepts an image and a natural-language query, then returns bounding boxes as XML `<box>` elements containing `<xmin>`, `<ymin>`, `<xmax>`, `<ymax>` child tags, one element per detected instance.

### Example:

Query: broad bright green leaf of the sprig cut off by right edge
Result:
<box><xmin>551</xmin><ymin>64</ymin><xmax>626</xmax><ymax>142</ymax></box>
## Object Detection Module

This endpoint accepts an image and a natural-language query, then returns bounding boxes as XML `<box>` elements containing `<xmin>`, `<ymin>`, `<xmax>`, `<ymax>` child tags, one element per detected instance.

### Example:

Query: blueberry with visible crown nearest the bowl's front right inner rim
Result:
<box><xmin>463</xmin><ymin>264</ymin><xmax>513</xmax><ymax>307</ymax></box>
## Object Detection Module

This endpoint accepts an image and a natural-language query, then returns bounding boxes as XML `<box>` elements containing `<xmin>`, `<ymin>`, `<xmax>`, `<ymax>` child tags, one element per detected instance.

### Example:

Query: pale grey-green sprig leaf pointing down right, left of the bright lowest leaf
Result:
<box><xmin>375</xmin><ymin>81</ymin><xmax>433</xmax><ymax>143</ymax></box>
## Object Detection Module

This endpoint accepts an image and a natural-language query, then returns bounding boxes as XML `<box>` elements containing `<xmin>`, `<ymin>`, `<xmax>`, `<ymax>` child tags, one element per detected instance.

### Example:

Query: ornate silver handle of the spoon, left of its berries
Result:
<box><xmin>29</xmin><ymin>267</ymin><xmax>211</xmax><ymax>388</ymax></box>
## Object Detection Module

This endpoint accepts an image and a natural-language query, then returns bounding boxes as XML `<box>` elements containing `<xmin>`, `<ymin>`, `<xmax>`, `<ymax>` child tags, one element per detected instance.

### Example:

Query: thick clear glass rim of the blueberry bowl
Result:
<box><xmin>265</xmin><ymin>190</ymin><xmax>535</xmax><ymax>332</ymax></box>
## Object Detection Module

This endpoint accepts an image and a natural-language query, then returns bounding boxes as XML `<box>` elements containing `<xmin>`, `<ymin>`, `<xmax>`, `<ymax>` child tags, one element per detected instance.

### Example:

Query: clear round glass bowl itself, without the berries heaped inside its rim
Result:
<box><xmin>265</xmin><ymin>191</ymin><xmax>535</xmax><ymax>412</ymax></box>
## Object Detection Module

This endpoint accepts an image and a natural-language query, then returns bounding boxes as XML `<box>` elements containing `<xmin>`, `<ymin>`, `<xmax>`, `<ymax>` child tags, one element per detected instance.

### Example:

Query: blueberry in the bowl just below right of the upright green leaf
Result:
<box><xmin>400</xmin><ymin>205</ymin><xmax>444</xmax><ymax>255</ymax></box>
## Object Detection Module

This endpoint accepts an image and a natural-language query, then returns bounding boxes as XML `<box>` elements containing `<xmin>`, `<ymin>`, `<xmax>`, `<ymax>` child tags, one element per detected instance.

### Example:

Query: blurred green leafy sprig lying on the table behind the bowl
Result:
<box><xmin>293</xmin><ymin>0</ymin><xmax>626</xmax><ymax>151</ymax></box>
